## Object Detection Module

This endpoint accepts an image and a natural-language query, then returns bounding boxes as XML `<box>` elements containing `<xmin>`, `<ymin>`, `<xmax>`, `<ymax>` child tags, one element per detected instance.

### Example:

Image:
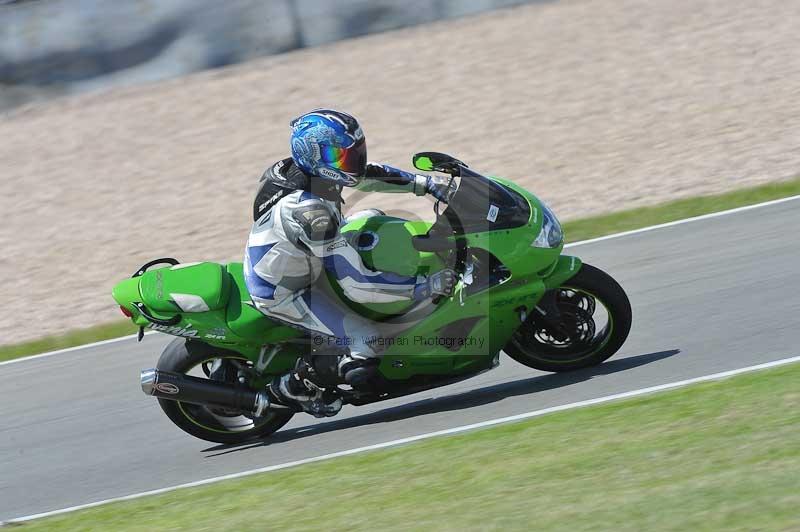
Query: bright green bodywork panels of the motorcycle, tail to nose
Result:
<box><xmin>113</xmin><ymin>178</ymin><xmax>581</xmax><ymax>386</ymax></box>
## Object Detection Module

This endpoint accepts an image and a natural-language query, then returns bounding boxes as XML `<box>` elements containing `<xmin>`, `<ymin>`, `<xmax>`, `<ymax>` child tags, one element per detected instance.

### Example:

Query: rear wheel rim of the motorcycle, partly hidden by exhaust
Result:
<box><xmin>175</xmin><ymin>356</ymin><xmax>277</xmax><ymax>434</ymax></box>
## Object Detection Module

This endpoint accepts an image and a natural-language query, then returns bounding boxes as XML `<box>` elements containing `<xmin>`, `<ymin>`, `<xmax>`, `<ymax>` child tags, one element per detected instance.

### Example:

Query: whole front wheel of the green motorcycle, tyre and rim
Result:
<box><xmin>504</xmin><ymin>264</ymin><xmax>632</xmax><ymax>372</ymax></box>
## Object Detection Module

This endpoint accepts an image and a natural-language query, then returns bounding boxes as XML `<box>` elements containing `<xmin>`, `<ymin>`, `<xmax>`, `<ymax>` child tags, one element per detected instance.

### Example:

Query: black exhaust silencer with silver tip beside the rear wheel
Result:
<box><xmin>140</xmin><ymin>369</ymin><xmax>270</xmax><ymax>417</ymax></box>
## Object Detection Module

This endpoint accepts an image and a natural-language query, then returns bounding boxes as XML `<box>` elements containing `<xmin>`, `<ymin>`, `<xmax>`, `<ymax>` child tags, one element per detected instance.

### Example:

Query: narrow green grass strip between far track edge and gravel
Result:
<box><xmin>0</xmin><ymin>178</ymin><xmax>800</xmax><ymax>361</ymax></box>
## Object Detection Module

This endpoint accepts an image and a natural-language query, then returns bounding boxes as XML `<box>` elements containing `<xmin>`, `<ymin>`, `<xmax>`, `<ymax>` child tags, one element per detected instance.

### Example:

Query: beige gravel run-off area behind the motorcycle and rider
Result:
<box><xmin>0</xmin><ymin>0</ymin><xmax>800</xmax><ymax>343</ymax></box>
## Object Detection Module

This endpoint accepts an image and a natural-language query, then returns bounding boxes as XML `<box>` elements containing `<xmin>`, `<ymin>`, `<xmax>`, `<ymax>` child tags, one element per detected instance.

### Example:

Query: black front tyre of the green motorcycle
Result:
<box><xmin>504</xmin><ymin>264</ymin><xmax>632</xmax><ymax>372</ymax></box>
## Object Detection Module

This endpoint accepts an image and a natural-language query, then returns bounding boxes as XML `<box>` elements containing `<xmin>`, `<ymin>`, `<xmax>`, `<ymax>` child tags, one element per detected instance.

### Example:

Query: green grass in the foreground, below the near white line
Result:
<box><xmin>19</xmin><ymin>364</ymin><xmax>800</xmax><ymax>532</ymax></box>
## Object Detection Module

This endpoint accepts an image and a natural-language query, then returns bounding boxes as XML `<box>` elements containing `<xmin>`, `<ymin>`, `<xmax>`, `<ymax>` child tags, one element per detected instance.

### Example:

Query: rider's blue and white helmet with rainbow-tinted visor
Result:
<box><xmin>291</xmin><ymin>109</ymin><xmax>367</xmax><ymax>187</ymax></box>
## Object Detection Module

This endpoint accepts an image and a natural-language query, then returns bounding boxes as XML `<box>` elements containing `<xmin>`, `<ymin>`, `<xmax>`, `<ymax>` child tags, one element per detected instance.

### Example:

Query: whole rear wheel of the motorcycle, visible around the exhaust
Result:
<box><xmin>156</xmin><ymin>338</ymin><xmax>294</xmax><ymax>443</ymax></box>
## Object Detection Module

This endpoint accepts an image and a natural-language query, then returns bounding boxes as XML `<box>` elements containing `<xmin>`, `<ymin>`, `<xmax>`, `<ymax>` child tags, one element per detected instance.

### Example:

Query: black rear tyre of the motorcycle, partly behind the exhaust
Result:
<box><xmin>156</xmin><ymin>338</ymin><xmax>294</xmax><ymax>444</ymax></box>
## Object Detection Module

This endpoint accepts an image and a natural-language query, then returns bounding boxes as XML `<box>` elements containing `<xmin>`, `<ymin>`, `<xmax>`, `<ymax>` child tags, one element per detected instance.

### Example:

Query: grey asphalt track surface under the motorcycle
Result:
<box><xmin>0</xmin><ymin>200</ymin><xmax>800</xmax><ymax>521</ymax></box>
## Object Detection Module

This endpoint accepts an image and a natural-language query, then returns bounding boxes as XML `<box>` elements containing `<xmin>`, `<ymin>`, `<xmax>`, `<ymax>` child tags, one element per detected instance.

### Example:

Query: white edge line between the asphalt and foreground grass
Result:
<box><xmin>7</xmin><ymin>356</ymin><xmax>800</xmax><ymax>526</ymax></box>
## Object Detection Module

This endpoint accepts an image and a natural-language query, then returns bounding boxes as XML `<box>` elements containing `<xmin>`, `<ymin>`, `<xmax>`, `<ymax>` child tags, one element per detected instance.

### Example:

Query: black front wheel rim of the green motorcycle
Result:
<box><xmin>511</xmin><ymin>286</ymin><xmax>614</xmax><ymax>364</ymax></box>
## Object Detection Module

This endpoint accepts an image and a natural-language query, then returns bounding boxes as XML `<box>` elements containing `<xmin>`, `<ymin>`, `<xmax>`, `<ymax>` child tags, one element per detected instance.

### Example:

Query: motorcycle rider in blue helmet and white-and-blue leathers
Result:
<box><xmin>244</xmin><ymin>109</ymin><xmax>456</xmax><ymax>417</ymax></box>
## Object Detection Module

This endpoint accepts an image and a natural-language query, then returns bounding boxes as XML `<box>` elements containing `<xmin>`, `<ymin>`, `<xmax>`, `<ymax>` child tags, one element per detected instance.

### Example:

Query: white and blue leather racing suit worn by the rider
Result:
<box><xmin>244</xmin><ymin>158</ymin><xmax>444</xmax><ymax>358</ymax></box>
